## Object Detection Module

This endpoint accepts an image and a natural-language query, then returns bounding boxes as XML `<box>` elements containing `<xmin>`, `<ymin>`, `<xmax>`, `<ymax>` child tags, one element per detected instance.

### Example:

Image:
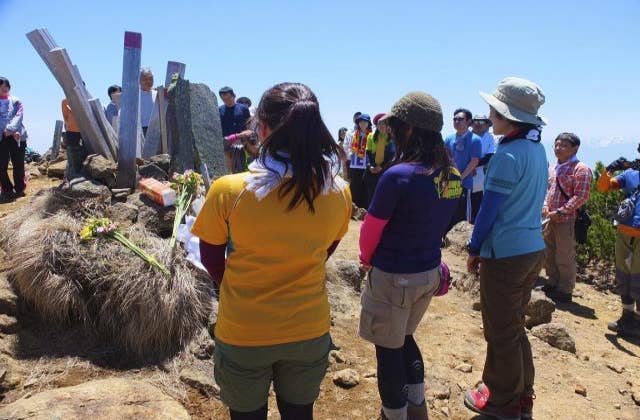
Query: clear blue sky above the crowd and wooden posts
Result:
<box><xmin>5</xmin><ymin>0</ymin><xmax>640</xmax><ymax>167</ymax></box>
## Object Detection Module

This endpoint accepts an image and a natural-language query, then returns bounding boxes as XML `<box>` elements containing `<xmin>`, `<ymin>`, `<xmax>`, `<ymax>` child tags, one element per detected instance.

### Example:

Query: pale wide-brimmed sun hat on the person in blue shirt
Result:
<box><xmin>479</xmin><ymin>77</ymin><xmax>547</xmax><ymax>125</ymax></box>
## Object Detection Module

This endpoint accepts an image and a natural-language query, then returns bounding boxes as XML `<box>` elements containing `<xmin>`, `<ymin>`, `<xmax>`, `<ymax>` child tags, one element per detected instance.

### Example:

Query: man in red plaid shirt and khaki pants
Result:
<box><xmin>542</xmin><ymin>133</ymin><xmax>593</xmax><ymax>303</ymax></box>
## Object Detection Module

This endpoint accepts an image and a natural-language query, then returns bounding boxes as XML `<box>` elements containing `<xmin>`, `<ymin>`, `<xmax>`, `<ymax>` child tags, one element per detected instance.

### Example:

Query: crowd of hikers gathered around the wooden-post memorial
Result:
<box><xmin>0</xmin><ymin>69</ymin><xmax>640</xmax><ymax>420</ymax></box>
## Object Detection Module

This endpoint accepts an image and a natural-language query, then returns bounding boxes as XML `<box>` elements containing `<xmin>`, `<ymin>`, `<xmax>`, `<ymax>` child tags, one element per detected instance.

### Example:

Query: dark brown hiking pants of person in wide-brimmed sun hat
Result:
<box><xmin>480</xmin><ymin>251</ymin><xmax>544</xmax><ymax>407</ymax></box>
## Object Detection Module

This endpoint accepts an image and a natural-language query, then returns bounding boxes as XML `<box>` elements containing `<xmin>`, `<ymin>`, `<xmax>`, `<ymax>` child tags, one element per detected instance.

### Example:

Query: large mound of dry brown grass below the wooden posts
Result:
<box><xmin>0</xmin><ymin>190</ymin><xmax>213</xmax><ymax>358</ymax></box>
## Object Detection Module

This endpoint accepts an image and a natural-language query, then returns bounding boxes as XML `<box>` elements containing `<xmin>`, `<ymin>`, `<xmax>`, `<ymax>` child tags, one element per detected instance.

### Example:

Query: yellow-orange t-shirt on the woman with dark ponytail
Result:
<box><xmin>192</xmin><ymin>173</ymin><xmax>351</xmax><ymax>346</ymax></box>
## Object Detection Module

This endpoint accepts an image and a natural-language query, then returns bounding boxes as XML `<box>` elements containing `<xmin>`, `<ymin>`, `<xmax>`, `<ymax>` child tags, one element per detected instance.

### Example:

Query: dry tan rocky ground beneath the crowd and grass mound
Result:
<box><xmin>0</xmin><ymin>168</ymin><xmax>640</xmax><ymax>420</ymax></box>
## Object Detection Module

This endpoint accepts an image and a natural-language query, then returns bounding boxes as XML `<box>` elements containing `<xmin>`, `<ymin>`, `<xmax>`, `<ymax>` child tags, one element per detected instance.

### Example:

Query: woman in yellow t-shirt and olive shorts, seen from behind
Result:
<box><xmin>193</xmin><ymin>83</ymin><xmax>351</xmax><ymax>420</ymax></box>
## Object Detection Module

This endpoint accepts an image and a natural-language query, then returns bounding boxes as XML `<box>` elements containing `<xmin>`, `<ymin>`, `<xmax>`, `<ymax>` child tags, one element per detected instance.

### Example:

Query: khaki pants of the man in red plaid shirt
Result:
<box><xmin>542</xmin><ymin>219</ymin><xmax>576</xmax><ymax>293</ymax></box>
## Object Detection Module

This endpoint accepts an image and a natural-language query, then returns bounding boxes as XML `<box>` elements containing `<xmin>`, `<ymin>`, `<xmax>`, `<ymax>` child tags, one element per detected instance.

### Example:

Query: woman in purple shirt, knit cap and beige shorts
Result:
<box><xmin>359</xmin><ymin>92</ymin><xmax>462</xmax><ymax>420</ymax></box>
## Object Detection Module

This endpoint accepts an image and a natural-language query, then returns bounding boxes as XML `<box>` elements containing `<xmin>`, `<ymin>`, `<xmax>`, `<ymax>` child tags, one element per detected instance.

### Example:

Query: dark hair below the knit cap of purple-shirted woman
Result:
<box><xmin>387</xmin><ymin>117</ymin><xmax>451</xmax><ymax>180</ymax></box>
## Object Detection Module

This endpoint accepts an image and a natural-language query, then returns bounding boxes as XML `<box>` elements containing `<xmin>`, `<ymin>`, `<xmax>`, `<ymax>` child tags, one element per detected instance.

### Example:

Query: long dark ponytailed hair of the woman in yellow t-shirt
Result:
<box><xmin>256</xmin><ymin>83</ymin><xmax>345</xmax><ymax>213</ymax></box>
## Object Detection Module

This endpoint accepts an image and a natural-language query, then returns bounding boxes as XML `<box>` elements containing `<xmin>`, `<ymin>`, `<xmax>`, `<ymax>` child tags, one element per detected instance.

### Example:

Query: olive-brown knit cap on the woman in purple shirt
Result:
<box><xmin>380</xmin><ymin>91</ymin><xmax>444</xmax><ymax>133</ymax></box>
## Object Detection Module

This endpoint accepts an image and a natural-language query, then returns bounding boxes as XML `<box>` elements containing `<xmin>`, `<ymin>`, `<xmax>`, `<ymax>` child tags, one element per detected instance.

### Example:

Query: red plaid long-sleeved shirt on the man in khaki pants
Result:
<box><xmin>544</xmin><ymin>159</ymin><xmax>593</xmax><ymax>223</ymax></box>
